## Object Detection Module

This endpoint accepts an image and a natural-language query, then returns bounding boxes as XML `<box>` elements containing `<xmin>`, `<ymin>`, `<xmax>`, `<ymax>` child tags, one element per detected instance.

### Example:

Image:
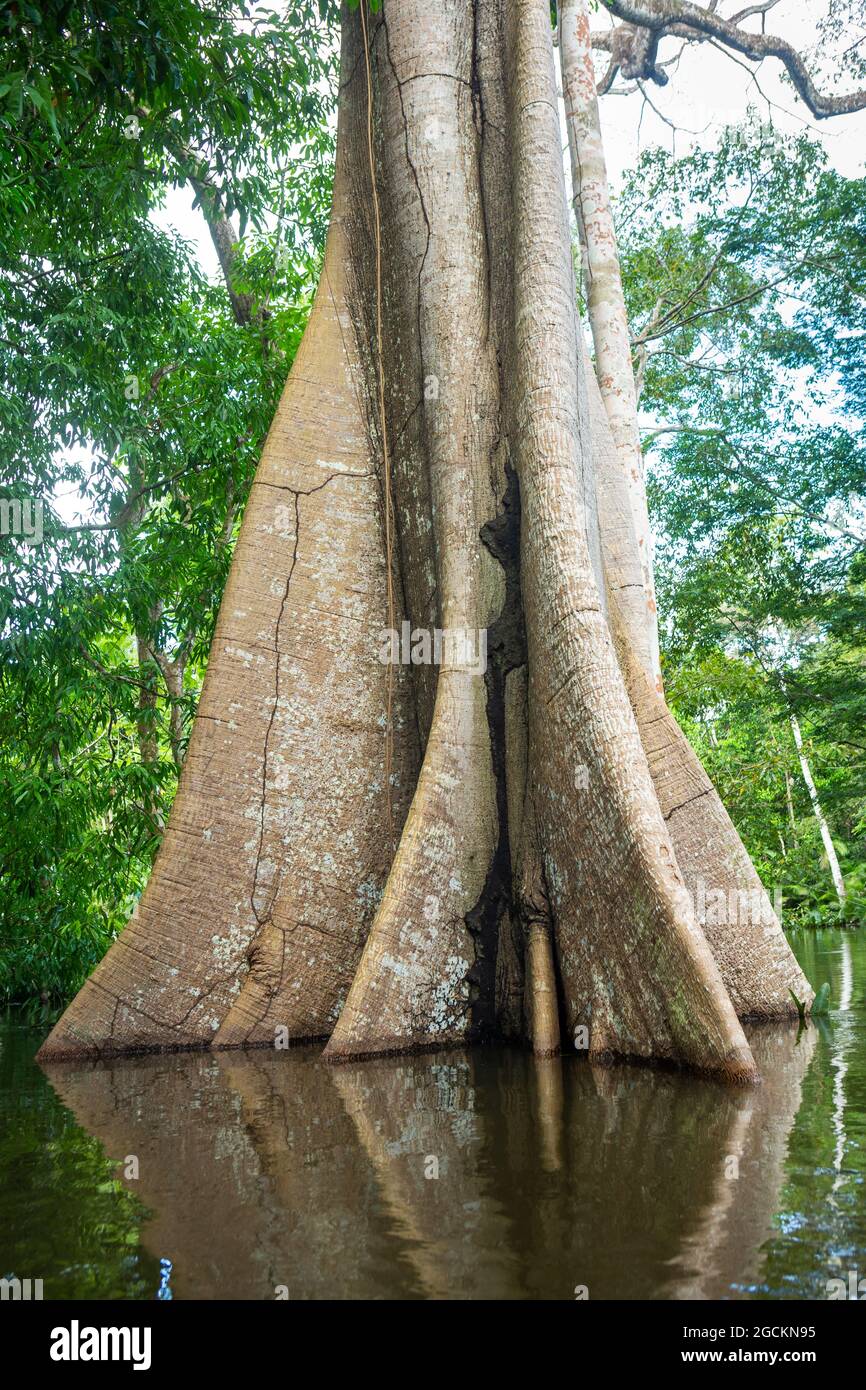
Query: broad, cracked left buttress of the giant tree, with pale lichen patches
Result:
<box><xmin>43</xmin><ymin>95</ymin><xmax>417</xmax><ymax>1056</ymax></box>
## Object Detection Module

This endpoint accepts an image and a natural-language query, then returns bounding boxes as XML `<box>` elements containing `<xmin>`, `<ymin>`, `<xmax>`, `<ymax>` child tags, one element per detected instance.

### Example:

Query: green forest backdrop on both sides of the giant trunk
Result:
<box><xmin>0</xmin><ymin>0</ymin><xmax>866</xmax><ymax>1009</ymax></box>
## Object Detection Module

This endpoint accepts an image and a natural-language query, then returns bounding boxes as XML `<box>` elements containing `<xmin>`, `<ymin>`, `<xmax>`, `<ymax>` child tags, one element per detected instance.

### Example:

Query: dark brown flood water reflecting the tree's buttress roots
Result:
<box><xmin>0</xmin><ymin>931</ymin><xmax>866</xmax><ymax>1300</ymax></box>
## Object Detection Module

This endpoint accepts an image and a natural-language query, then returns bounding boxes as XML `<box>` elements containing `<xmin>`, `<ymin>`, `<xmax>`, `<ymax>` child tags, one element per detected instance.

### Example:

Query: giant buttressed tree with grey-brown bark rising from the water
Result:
<box><xmin>42</xmin><ymin>0</ymin><xmax>866</xmax><ymax>1080</ymax></box>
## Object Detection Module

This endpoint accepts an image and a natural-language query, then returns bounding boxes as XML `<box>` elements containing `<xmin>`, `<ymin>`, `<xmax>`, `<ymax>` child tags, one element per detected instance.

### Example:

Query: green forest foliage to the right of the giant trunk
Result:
<box><xmin>619</xmin><ymin>121</ymin><xmax>866</xmax><ymax>924</ymax></box>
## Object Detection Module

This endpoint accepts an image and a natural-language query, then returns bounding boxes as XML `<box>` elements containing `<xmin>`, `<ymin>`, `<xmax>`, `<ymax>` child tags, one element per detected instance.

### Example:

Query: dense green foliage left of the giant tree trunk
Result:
<box><xmin>0</xmin><ymin>0</ymin><xmax>335</xmax><ymax>1009</ymax></box>
